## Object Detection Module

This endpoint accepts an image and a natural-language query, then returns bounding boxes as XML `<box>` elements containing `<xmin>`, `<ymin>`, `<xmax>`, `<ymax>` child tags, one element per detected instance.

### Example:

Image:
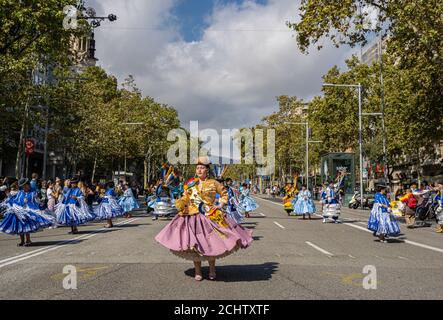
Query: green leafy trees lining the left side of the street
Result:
<box><xmin>0</xmin><ymin>0</ymin><xmax>180</xmax><ymax>185</ymax></box>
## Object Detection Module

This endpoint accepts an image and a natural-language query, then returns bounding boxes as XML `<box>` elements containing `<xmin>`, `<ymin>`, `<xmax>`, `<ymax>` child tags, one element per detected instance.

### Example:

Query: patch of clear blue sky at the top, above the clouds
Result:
<box><xmin>171</xmin><ymin>0</ymin><xmax>268</xmax><ymax>42</ymax></box>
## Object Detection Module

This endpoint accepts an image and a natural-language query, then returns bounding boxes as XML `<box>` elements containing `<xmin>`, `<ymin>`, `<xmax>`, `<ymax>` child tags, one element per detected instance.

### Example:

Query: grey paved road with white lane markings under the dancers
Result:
<box><xmin>0</xmin><ymin>198</ymin><xmax>443</xmax><ymax>300</ymax></box>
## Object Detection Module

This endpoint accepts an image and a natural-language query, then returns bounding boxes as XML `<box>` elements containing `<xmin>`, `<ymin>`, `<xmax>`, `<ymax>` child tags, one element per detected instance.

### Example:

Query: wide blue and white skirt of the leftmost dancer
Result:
<box><xmin>0</xmin><ymin>204</ymin><xmax>54</xmax><ymax>234</ymax></box>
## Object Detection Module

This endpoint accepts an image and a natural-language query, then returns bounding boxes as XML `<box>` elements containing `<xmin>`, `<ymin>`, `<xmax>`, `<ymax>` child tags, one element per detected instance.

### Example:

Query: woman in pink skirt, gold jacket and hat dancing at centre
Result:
<box><xmin>155</xmin><ymin>158</ymin><xmax>252</xmax><ymax>281</ymax></box>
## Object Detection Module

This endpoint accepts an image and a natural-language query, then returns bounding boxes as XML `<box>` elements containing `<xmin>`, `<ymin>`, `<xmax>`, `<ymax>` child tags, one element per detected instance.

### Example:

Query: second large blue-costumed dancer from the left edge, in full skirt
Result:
<box><xmin>55</xmin><ymin>178</ymin><xmax>95</xmax><ymax>234</ymax></box>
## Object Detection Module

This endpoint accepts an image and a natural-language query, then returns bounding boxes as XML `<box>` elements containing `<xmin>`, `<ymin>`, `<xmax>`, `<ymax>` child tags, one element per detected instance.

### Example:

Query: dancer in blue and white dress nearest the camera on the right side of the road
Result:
<box><xmin>368</xmin><ymin>185</ymin><xmax>400</xmax><ymax>243</ymax></box>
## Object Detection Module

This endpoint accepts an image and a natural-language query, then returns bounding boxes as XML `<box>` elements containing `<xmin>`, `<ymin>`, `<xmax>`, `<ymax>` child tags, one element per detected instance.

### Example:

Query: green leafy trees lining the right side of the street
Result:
<box><xmin>246</xmin><ymin>0</ymin><xmax>443</xmax><ymax>185</ymax></box>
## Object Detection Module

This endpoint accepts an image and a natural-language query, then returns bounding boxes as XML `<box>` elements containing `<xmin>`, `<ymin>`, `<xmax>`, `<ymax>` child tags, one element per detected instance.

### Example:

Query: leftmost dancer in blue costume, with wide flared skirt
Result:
<box><xmin>0</xmin><ymin>179</ymin><xmax>54</xmax><ymax>247</ymax></box>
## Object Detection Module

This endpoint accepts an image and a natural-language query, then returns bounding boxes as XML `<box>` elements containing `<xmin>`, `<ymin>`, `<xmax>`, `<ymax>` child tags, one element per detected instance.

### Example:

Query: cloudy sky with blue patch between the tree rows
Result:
<box><xmin>87</xmin><ymin>0</ymin><xmax>360</xmax><ymax>129</ymax></box>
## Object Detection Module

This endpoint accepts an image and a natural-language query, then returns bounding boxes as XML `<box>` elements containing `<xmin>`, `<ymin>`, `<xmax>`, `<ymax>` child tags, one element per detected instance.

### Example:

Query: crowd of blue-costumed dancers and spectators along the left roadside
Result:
<box><xmin>0</xmin><ymin>173</ymin><xmax>139</xmax><ymax>246</ymax></box>
